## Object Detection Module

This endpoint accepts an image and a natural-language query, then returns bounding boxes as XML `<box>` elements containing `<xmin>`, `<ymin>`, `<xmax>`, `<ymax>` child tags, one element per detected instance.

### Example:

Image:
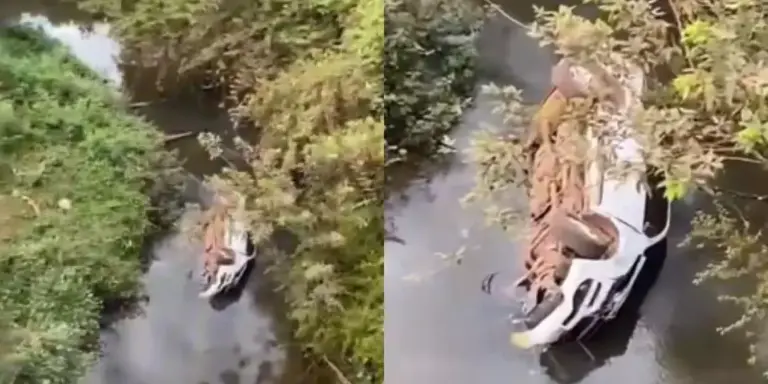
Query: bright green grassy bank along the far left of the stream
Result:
<box><xmin>0</xmin><ymin>27</ymin><xmax>179</xmax><ymax>383</ymax></box>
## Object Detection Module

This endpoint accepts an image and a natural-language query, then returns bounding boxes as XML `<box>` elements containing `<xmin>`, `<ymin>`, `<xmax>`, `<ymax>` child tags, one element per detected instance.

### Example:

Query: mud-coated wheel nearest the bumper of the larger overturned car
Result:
<box><xmin>550</xmin><ymin>214</ymin><xmax>610</xmax><ymax>259</ymax></box>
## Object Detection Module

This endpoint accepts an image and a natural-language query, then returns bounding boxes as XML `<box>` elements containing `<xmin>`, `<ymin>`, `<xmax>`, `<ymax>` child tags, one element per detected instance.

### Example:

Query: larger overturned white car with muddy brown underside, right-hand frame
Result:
<box><xmin>500</xmin><ymin>61</ymin><xmax>670</xmax><ymax>348</ymax></box>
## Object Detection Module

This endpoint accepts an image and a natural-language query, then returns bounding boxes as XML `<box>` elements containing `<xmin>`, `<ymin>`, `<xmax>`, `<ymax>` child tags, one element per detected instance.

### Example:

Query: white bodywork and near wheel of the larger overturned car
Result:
<box><xmin>500</xmin><ymin>58</ymin><xmax>670</xmax><ymax>348</ymax></box>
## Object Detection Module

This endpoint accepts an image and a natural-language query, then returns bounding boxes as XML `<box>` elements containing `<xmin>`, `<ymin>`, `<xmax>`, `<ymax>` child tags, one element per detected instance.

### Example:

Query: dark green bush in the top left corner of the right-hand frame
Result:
<box><xmin>384</xmin><ymin>0</ymin><xmax>482</xmax><ymax>159</ymax></box>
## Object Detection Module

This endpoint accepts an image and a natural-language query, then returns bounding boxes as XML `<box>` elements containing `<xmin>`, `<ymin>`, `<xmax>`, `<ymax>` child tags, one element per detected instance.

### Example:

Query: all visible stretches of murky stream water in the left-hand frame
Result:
<box><xmin>0</xmin><ymin>5</ymin><xmax>304</xmax><ymax>384</ymax></box>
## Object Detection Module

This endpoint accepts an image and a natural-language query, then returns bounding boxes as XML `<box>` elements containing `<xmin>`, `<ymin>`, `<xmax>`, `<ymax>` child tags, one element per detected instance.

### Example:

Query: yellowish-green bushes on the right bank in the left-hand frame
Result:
<box><xmin>73</xmin><ymin>0</ymin><xmax>384</xmax><ymax>383</ymax></box>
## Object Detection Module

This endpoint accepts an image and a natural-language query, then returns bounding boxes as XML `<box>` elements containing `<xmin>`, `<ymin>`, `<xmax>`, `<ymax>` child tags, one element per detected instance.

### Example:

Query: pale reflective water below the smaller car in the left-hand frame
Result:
<box><xmin>86</xmin><ymin>228</ymin><xmax>286</xmax><ymax>384</ymax></box>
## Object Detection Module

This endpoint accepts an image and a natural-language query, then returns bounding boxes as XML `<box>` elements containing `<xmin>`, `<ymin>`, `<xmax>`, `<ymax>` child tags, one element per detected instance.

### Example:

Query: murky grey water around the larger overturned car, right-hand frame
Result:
<box><xmin>385</xmin><ymin>2</ymin><xmax>765</xmax><ymax>384</ymax></box>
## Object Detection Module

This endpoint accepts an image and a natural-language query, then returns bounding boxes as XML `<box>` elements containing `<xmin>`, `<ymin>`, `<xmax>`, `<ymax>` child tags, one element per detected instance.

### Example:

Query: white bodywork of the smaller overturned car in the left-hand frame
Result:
<box><xmin>200</xmin><ymin>217</ymin><xmax>256</xmax><ymax>298</ymax></box>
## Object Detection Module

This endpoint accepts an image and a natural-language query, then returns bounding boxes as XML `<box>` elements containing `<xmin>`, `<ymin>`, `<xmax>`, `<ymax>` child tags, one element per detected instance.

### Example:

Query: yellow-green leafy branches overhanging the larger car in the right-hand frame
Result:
<box><xmin>472</xmin><ymin>0</ymin><xmax>768</xmax><ymax>370</ymax></box>
